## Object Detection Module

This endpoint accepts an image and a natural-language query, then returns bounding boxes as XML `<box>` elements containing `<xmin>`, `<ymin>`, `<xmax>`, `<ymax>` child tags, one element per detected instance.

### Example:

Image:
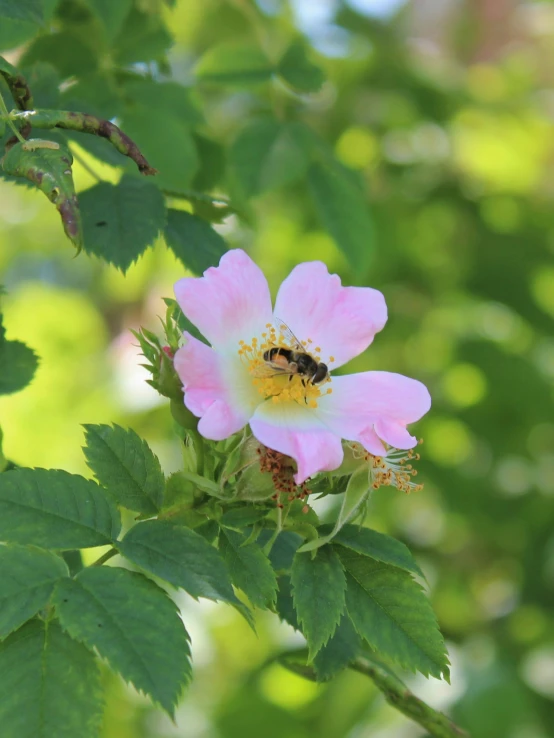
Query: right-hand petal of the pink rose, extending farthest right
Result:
<box><xmin>315</xmin><ymin>372</ymin><xmax>431</xmax><ymax>448</ymax></box>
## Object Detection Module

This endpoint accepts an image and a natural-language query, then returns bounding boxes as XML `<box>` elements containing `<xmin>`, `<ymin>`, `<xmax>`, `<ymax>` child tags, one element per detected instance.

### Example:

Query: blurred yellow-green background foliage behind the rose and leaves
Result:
<box><xmin>0</xmin><ymin>0</ymin><xmax>554</xmax><ymax>738</ymax></box>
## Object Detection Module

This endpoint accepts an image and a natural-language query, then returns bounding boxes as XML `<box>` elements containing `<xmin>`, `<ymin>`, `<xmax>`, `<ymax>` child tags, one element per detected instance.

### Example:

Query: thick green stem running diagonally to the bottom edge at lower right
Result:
<box><xmin>350</xmin><ymin>656</ymin><xmax>469</xmax><ymax>738</ymax></box>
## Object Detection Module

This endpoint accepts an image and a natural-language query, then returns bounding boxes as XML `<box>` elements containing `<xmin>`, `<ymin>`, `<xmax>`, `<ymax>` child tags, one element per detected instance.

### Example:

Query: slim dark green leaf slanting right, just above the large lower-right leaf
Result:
<box><xmin>330</xmin><ymin>525</ymin><xmax>425</xmax><ymax>579</ymax></box>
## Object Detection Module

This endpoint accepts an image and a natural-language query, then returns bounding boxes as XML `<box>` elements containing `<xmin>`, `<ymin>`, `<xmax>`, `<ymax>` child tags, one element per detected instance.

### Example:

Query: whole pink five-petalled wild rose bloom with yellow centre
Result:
<box><xmin>175</xmin><ymin>249</ymin><xmax>431</xmax><ymax>485</ymax></box>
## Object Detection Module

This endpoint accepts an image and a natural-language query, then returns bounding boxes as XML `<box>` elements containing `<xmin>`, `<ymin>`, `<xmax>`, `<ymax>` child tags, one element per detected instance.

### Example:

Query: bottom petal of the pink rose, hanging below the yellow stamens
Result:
<box><xmin>250</xmin><ymin>402</ymin><xmax>343</xmax><ymax>484</ymax></box>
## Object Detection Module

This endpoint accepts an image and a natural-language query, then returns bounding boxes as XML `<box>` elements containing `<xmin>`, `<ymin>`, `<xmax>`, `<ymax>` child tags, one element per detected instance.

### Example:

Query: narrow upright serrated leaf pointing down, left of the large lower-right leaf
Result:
<box><xmin>291</xmin><ymin>546</ymin><xmax>346</xmax><ymax>659</ymax></box>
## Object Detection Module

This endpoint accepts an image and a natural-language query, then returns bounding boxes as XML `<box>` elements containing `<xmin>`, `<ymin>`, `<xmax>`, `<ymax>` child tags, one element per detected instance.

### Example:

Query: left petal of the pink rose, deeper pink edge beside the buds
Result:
<box><xmin>174</xmin><ymin>333</ymin><xmax>260</xmax><ymax>441</ymax></box>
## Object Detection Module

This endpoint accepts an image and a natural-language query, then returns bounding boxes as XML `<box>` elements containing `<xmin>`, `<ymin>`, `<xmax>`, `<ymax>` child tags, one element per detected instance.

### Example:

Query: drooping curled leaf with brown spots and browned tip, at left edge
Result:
<box><xmin>2</xmin><ymin>139</ymin><xmax>83</xmax><ymax>251</ymax></box>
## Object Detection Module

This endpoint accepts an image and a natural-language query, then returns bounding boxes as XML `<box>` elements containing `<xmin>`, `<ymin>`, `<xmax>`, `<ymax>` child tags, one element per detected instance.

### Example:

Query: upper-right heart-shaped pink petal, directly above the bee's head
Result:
<box><xmin>275</xmin><ymin>261</ymin><xmax>387</xmax><ymax>369</ymax></box>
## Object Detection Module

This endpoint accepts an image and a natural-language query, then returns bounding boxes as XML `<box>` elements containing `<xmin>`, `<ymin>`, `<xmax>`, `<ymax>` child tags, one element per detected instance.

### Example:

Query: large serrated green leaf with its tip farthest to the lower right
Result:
<box><xmin>339</xmin><ymin>548</ymin><xmax>449</xmax><ymax>679</ymax></box>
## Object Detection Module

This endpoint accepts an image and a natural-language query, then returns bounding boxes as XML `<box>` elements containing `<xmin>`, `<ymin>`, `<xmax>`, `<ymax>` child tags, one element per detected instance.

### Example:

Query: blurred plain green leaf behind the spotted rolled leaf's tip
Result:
<box><xmin>121</xmin><ymin>105</ymin><xmax>198</xmax><ymax>193</ymax></box>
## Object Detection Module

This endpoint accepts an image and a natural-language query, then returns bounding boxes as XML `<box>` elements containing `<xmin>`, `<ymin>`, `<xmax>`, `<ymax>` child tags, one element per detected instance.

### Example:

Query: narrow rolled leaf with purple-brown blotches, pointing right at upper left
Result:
<box><xmin>10</xmin><ymin>110</ymin><xmax>157</xmax><ymax>175</ymax></box>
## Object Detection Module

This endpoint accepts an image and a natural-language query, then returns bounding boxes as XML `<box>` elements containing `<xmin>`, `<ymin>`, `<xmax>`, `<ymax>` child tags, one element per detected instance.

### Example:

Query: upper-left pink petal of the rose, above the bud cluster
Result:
<box><xmin>175</xmin><ymin>249</ymin><xmax>272</xmax><ymax>348</ymax></box>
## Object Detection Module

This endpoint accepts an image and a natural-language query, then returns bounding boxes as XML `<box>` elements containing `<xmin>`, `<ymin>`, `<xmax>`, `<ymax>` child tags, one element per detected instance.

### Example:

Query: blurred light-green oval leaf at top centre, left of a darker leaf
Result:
<box><xmin>195</xmin><ymin>43</ymin><xmax>275</xmax><ymax>87</ymax></box>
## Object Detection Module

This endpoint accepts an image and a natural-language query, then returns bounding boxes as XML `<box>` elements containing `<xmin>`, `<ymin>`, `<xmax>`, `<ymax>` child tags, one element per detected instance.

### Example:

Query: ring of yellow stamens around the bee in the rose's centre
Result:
<box><xmin>237</xmin><ymin>323</ymin><xmax>332</xmax><ymax>409</ymax></box>
